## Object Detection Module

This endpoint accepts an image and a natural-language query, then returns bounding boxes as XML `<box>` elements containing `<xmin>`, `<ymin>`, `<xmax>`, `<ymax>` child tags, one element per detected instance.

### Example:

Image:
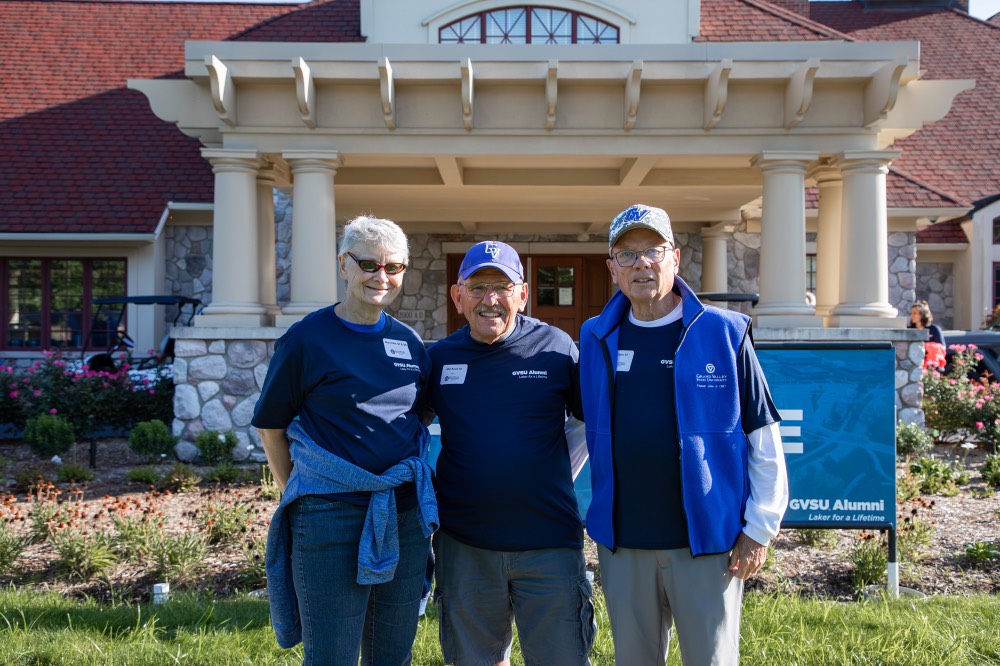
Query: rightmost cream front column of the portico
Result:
<box><xmin>827</xmin><ymin>150</ymin><xmax>906</xmax><ymax>328</ymax></box>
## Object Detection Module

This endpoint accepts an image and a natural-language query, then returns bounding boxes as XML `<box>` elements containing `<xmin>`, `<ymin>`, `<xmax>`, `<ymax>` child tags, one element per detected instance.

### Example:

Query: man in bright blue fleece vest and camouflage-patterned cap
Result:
<box><xmin>580</xmin><ymin>204</ymin><xmax>788</xmax><ymax>666</ymax></box>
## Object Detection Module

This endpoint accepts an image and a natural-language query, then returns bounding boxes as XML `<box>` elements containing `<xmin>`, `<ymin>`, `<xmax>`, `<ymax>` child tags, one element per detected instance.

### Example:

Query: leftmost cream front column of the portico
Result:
<box><xmin>194</xmin><ymin>148</ymin><xmax>265</xmax><ymax>326</ymax></box>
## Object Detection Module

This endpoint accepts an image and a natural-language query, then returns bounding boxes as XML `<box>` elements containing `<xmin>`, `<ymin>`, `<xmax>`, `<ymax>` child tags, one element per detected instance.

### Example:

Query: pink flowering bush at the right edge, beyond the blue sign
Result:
<box><xmin>923</xmin><ymin>345</ymin><xmax>1000</xmax><ymax>451</ymax></box>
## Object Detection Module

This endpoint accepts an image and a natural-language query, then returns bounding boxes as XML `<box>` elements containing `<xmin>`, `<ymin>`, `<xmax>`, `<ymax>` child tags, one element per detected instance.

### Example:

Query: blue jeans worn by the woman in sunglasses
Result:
<box><xmin>288</xmin><ymin>496</ymin><xmax>428</xmax><ymax>666</ymax></box>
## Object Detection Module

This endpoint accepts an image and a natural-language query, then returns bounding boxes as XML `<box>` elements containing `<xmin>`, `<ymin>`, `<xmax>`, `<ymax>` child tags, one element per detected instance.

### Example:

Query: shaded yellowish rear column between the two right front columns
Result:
<box><xmin>816</xmin><ymin>169</ymin><xmax>844</xmax><ymax>315</ymax></box>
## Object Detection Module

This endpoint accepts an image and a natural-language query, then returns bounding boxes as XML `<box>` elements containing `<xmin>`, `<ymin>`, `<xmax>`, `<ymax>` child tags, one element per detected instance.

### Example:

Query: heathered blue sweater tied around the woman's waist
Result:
<box><xmin>266</xmin><ymin>419</ymin><xmax>438</xmax><ymax>648</ymax></box>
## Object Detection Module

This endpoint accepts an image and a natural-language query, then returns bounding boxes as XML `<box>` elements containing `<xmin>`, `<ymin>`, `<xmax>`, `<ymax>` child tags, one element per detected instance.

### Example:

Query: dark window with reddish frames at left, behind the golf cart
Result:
<box><xmin>0</xmin><ymin>257</ymin><xmax>126</xmax><ymax>350</ymax></box>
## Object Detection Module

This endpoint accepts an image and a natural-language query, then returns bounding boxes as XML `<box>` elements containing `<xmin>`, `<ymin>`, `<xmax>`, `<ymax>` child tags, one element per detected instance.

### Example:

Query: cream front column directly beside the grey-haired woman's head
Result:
<box><xmin>275</xmin><ymin>150</ymin><xmax>340</xmax><ymax>327</ymax></box>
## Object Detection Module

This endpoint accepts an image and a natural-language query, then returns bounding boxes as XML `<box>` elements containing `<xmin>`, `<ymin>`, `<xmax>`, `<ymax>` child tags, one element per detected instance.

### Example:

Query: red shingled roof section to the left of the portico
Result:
<box><xmin>0</xmin><ymin>0</ymin><xmax>360</xmax><ymax>233</ymax></box>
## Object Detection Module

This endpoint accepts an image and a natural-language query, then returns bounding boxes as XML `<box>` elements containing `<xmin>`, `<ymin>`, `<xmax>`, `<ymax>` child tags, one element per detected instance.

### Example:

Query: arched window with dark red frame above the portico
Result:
<box><xmin>438</xmin><ymin>6</ymin><xmax>618</xmax><ymax>44</ymax></box>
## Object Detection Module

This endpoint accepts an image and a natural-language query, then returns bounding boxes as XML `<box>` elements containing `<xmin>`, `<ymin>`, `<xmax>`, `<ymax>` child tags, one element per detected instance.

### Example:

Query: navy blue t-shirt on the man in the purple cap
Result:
<box><xmin>428</xmin><ymin>315</ymin><xmax>583</xmax><ymax>551</ymax></box>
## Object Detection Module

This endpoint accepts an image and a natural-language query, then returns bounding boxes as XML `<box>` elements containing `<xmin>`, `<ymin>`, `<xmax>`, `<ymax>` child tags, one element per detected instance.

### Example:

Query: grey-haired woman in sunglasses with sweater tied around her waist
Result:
<box><xmin>252</xmin><ymin>217</ymin><xmax>437</xmax><ymax>666</ymax></box>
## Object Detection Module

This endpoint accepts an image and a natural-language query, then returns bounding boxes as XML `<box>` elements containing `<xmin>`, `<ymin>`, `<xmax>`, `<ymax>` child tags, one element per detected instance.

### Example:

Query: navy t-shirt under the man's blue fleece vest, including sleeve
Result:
<box><xmin>612</xmin><ymin>307</ymin><xmax>778</xmax><ymax>550</ymax></box>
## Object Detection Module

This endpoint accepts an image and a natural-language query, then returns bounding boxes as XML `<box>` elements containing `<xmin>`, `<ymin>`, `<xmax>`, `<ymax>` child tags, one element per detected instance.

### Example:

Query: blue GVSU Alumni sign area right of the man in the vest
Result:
<box><xmin>757</xmin><ymin>344</ymin><xmax>896</xmax><ymax>528</ymax></box>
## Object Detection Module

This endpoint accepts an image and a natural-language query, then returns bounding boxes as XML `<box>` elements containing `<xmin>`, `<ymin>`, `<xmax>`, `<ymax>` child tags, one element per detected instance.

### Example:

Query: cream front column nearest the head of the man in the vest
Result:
<box><xmin>751</xmin><ymin>152</ymin><xmax>823</xmax><ymax>328</ymax></box>
